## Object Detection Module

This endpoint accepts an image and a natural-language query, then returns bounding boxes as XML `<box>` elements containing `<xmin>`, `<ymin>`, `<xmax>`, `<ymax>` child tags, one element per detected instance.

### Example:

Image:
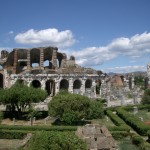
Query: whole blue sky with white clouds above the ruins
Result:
<box><xmin>0</xmin><ymin>0</ymin><xmax>150</xmax><ymax>73</ymax></box>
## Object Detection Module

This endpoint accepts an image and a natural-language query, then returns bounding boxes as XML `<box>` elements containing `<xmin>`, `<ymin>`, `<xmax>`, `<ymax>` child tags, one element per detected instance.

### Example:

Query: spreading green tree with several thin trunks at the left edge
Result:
<box><xmin>0</xmin><ymin>83</ymin><xmax>47</xmax><ymax>117</ymax></box>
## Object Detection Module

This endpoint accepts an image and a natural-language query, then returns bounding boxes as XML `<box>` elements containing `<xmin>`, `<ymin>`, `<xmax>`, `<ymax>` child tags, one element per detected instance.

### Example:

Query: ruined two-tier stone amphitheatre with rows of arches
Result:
<box><xmin>0</xmin><ymin>47</ymin><xmax>101</xmax><ymax>98</ymax></box>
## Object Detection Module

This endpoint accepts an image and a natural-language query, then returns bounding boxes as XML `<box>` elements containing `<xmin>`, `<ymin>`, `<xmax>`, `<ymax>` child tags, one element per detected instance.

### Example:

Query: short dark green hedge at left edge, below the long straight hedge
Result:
<box><xmin>0</xmin><ymin>130</ymin><xmax>27</xmax><ymax>139</ymax></box>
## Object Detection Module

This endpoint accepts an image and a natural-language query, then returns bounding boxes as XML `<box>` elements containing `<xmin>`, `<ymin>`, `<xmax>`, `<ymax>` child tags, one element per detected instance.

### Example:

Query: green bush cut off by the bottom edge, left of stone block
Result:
<box><xmin>26</xmin><ymin>132</ymin><xmax>87</xmax><ymax>150</ymax></box>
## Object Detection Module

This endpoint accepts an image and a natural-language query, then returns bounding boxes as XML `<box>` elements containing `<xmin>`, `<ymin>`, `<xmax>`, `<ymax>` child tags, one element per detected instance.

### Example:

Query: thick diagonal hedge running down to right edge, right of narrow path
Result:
<box><xmin>116</xmin><ymin>108</ymin><xmax>150</xmax><ymax>135</ymax></box>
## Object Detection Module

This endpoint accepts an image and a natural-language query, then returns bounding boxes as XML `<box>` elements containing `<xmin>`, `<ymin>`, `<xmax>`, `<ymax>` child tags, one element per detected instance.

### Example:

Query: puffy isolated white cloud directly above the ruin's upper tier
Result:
<box><xmin>15</xmin><ymin>28</ymin><xmax>75</xmax><ymax>48</ymax></box>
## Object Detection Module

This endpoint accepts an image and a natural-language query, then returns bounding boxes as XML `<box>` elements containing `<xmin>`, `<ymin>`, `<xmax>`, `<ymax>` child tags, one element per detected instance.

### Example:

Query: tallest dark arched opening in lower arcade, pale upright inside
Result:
<box><xmin>45</xmin><ymin>80</ymin><xmax>55</xmax><ymax>96</ymax></box>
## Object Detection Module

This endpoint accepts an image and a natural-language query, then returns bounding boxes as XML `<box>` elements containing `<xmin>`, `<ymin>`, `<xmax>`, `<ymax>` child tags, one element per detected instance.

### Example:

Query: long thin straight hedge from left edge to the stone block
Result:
<box><xmin>0</xmin><ymin>125</ymin><xmax>77</xmax><ymax>131</ymax></box>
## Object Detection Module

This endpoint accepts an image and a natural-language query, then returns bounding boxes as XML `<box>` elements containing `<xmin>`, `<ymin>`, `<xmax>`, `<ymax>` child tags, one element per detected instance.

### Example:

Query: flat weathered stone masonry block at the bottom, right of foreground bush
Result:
<box><xmin>76</xmin><ymin>124</ymin><xmax>117</xmax><ymax>150</ymax></box>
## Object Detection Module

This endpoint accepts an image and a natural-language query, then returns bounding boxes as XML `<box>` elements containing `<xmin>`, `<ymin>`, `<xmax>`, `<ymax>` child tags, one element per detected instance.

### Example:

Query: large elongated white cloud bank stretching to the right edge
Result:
<box><xmin>72</xmin><ymin>32</ymin><xmax>150</xmax><ymax>66</ymax></box>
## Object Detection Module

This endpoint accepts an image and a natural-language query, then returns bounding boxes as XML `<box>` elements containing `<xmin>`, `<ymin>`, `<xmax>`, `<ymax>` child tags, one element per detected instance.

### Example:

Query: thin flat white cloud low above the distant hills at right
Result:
<box><xmin>104</xmin><ymin>66</ymin><xmax>146</xmax><ymax>73</ymax></box>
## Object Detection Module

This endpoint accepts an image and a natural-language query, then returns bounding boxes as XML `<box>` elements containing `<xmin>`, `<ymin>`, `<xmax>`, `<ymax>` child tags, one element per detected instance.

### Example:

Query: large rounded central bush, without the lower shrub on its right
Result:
<box><xmin>49</xmin><ymin>92</ymin><xmax>90</xmax><ymax>124</ymax></box>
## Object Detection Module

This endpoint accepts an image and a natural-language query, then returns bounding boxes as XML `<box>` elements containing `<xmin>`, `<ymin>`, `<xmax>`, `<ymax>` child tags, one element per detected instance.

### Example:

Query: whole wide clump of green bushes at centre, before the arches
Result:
<box><xmin>49</xmin><ymin>92</ymin><xmax>103</xmax><ymax>125</ymax></box>
